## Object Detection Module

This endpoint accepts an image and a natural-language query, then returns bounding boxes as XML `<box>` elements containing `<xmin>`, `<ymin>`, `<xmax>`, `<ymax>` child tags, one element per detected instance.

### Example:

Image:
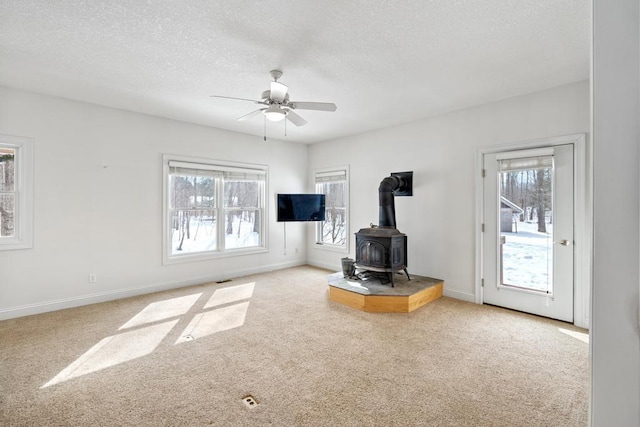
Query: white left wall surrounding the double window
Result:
<box><xmin>0</xmin><ymin>87</ymin><xmax>308</xmax><ymax>319</ymax></box>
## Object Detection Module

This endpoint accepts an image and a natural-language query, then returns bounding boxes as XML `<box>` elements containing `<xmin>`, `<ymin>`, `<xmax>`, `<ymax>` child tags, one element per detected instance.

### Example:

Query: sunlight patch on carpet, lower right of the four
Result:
<box><xmin>176</xmin><ymin>302</ymin><xmax>249</xmax><ymax>344</ymax></box>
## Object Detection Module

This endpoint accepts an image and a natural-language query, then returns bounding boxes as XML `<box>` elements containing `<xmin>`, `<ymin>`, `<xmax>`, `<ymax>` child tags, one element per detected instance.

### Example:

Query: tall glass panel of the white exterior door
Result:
<box><xmin>498</xmin><ymin>155</ymin><xmax>553</xmax><ymax>294</ymax></box>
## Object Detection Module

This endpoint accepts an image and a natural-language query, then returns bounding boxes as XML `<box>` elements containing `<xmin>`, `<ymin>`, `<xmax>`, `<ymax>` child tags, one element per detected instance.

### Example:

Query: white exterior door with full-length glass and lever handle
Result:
<box><xmin>482</xmin><ymin>144</ymin><xmax>574</xmax><ymax>322</ymax></box>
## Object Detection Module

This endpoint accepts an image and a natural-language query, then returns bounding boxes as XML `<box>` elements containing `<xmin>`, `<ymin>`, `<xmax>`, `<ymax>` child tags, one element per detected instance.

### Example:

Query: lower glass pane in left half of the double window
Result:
<box><xmin>171</xmin><ymin>209</ymin><xmax>217</xmax><ymax>255</ymax></box>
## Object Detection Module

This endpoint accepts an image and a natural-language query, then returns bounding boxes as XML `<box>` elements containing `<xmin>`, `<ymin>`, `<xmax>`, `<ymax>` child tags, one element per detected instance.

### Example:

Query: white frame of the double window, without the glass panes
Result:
<box><xmin>162</xmin><ymin>154</ymin><xmax>269</xmax><ymax>265</ymax></box>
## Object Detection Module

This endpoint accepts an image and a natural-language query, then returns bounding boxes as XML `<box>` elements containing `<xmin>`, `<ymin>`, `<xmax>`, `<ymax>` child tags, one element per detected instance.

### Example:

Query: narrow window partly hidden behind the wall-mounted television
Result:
<box><xmin>314</xmin><ymin>167</ymin><xmax>349</xmax><ymax>250</ymax></box>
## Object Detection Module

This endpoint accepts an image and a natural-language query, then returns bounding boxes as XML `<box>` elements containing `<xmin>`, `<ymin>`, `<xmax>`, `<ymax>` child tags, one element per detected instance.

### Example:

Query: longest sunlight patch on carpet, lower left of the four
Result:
<box><xmin>40</xmin><ymin>319</ymin><xmax>178</xmax><ymax>388</ymax></box>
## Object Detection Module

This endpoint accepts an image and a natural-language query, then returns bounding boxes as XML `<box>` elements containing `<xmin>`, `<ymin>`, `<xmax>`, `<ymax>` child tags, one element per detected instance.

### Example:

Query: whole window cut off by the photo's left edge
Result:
<box><xmin>0</xmin><ymin>135</ymin><xmax>33</xmax><ymax>250</ymax></box>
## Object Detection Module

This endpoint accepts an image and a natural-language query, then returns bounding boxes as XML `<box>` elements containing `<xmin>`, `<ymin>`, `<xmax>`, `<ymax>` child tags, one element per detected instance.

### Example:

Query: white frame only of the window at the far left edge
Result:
<box><xmin>0</xmin><ymin>135</ymin><xmax>33</xmax><ymax>251</ymax></box>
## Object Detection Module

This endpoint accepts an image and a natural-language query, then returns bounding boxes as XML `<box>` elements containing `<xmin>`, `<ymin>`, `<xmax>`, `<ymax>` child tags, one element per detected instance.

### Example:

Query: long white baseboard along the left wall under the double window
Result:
<box><xmin>0</xmin><ymin>260</ymin><xmax>306</xmax><ymax>320</ymax></box>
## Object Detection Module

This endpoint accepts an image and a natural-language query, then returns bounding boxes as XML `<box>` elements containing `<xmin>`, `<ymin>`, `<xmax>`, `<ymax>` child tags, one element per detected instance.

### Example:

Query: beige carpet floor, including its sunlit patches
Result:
<box><xmin>0</xmin><ymin>266</ymin><xmax>589</xmax><ymax>426</ymax></box>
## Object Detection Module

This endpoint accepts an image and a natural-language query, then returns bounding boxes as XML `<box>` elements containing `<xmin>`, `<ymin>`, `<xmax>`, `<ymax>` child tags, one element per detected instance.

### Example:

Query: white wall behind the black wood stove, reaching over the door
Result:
<box><xmin>308</xmin><ymin>81</ymin><xmax>590</xmax><ymax>301</ymax></box>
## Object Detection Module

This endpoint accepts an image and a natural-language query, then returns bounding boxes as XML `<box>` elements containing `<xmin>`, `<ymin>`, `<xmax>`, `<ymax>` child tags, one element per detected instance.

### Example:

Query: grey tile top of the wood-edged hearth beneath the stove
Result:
<box><xmin>329</xmin><ymin>272</ymin><xmax>442</xmax><ymax>296</ymax></box>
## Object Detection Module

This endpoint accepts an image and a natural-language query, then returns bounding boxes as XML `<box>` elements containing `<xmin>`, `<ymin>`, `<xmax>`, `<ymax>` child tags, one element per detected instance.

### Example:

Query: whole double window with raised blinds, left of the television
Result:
<box><xmin>164</xmin><ymin>156</ymin><xmax>267</xmax><ymax>263</ymax></box>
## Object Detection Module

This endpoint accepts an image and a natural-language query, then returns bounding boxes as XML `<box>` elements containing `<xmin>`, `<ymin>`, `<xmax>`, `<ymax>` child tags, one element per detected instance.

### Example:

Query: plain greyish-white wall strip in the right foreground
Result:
<box><xmin>591</xmin><ymin>0</ymin><xmax>640</xmax><ymax>426</ymax></box>
